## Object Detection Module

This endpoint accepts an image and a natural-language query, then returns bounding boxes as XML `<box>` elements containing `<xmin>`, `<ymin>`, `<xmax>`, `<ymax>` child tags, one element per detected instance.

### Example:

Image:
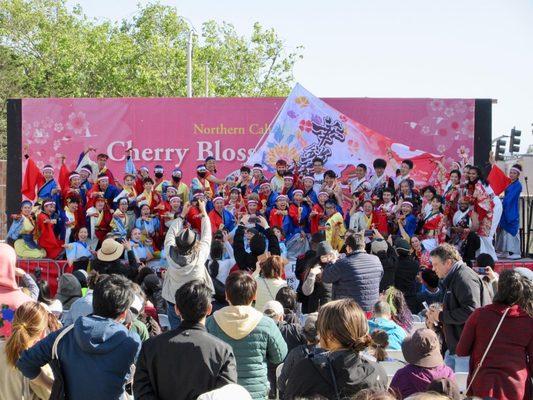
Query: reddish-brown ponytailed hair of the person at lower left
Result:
<box><xmin>5</xmin><ymin>301</ymin><xmax>49</xmax><ymax>367</ymax></box>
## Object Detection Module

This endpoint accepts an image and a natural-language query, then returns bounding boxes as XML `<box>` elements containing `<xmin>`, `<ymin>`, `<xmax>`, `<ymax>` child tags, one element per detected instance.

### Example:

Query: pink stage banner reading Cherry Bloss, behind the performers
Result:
<box><xmin>22</xmin><ymin>98</ymin><xmax>475</xmax><ymax>181</ymax></box>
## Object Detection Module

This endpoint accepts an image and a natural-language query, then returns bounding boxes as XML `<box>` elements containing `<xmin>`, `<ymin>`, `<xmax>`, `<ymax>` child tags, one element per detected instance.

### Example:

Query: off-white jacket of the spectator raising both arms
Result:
<box><xmin>162</xmin><ymin>217</ymin><xmax>215</xmax><ymax>304</ymax></box>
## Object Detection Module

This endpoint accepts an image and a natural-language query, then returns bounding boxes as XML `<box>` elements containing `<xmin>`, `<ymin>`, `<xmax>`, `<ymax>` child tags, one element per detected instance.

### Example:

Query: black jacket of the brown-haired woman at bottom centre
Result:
<box><xmin>285</xmin><ymin>350</ymin><xmax>388</xmax><ymax>400</ymax></box>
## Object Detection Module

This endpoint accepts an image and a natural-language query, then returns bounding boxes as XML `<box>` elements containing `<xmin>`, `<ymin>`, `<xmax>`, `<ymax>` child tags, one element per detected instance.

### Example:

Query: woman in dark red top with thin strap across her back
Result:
<box><xmin>456</xmin><ymin>270</ymin><xmax>533</xmax><ymax>400</ymax></box>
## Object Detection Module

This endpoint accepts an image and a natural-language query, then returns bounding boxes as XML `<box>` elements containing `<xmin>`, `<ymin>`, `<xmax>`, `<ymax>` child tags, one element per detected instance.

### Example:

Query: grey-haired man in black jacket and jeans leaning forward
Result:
<box><xmin>427</xmin><ymin>243</ymin><xmax>490</xmax><ymax>372</ymax></box>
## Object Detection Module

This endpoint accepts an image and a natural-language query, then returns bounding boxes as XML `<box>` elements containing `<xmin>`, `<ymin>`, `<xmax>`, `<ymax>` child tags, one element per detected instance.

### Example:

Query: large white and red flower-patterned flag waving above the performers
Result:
<box><xmin>247</xmin><ymin>84</ymin><xmax>442</xmax><ymax>183</ymax></box>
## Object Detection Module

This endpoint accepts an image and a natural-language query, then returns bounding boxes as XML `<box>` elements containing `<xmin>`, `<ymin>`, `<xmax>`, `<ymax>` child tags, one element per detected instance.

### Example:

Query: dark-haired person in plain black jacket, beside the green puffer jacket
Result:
<box><xmin>133</xmin><ymin>280</ymin><xmax>237</xmax><ymax>400</ymax></box>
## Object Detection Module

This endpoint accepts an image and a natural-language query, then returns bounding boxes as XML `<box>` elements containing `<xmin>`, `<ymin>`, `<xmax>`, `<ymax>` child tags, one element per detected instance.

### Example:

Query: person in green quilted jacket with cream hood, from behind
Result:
<box><xmin>206</xmin><ymin>271</ymin><xmax>287</xmax><ymax>399</ymax></box>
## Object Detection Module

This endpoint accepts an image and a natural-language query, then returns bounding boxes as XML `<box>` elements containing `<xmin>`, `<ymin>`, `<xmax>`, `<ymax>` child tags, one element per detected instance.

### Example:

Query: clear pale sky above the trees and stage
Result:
<box><xmin>68</xmin><ymin>0</ymin><xmax>533</xmax><ymax>151</ymax></box>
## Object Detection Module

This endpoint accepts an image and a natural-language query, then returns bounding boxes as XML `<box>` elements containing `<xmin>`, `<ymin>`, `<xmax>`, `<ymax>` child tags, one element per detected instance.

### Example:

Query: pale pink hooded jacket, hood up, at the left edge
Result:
<box><xmin>0</xmin><ymin>243</ymin><xmax>32</xmax><ymax>337</ymax></box>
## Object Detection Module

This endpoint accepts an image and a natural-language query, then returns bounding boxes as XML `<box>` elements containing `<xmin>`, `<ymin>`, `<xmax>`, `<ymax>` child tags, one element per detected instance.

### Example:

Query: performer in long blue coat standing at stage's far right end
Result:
<box><xmin>496</xmin><ymin>164</ymin><xmax>522</xmax><ymax>260</ymax></box>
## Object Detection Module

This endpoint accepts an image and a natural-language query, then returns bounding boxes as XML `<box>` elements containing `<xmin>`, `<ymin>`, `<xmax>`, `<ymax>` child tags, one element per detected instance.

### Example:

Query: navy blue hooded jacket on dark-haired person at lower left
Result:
<box><xmin>17</xmin><ymin>315</ymin><xmax>141</xmax><ymax>400</ymax></box>
